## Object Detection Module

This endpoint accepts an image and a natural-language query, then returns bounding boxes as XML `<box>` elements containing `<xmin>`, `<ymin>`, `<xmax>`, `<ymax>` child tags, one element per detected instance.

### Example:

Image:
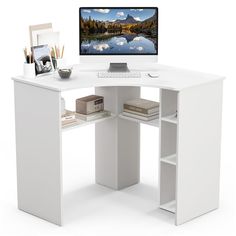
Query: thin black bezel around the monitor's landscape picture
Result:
<box><xmin>79</xmin><ymin>7</ymin><xmax>159</xmax><ymax>56</ymax></box>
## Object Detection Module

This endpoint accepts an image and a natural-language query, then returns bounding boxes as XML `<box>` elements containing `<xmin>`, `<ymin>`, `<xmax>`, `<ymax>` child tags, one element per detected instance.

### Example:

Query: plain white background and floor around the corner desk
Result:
<box><xmin>0</xmin><ymin>0</ymin><xmax>236</xmax><ymax>236</ymax></box>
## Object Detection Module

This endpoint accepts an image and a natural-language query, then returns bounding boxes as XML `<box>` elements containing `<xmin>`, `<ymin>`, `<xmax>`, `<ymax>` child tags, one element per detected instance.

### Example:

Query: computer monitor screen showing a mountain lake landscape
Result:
<box><xmin>79</xmin><ymin>7</ymin><xmax>158</xmax><ymax>55</ymax></box>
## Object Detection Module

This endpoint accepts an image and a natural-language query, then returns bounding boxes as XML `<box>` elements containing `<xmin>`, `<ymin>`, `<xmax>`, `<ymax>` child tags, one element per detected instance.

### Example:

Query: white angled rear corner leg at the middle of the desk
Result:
<box><xmin>96</xmin><ymin>87</ymin><xmax>140</xmax><ymax>189</ymax></box>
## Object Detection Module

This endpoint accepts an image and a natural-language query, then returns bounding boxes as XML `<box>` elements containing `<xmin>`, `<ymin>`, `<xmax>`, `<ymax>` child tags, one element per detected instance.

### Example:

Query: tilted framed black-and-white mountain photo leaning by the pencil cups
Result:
<box><xmin>31</xmin><ymin>45</ymin><xmax>54</xmax><ymax>75</ymax></box>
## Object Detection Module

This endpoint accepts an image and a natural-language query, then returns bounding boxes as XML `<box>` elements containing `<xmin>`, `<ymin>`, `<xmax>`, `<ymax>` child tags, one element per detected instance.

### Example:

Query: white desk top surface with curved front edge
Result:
<box><xmin>12</xmin><ymin>64</ymin><xmax>224</xmax><ymax>92</ymax></box>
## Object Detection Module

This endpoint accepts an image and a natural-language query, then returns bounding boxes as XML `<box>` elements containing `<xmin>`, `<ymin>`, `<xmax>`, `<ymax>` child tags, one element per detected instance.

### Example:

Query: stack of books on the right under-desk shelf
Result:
<box><xmin>123</xmin><ymin>98</ymin><xmax>159</xmax><ymax>121</ymax></box>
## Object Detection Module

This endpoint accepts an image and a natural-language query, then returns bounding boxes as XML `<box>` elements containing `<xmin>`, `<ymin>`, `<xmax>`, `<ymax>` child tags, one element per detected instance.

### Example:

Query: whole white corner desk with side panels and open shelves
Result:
<box><xmin>13</xmin><ymin>65</ymin><xmax>224</xmax><ymax>225</ymax></box>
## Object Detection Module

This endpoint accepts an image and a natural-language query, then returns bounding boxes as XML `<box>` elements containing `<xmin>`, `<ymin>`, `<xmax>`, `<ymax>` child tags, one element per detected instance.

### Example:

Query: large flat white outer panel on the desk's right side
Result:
<box><xmin>176</xmin><ymin>81</ymin><xmax>222</xmax><ymax>225</ymax></box>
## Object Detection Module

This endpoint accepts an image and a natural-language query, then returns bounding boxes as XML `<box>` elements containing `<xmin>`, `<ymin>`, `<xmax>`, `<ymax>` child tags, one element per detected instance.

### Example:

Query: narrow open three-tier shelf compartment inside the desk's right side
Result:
<box><xmin>160</xmin><ymin>89</ymin><xmax>178</xmax><ymax>213</ymax></box>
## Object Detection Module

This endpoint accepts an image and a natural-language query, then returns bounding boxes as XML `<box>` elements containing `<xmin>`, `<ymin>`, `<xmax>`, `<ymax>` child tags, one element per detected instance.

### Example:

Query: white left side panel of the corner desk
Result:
<box><xmin>14</xmin><ymin>82</ymin><xmax>62</xmax><ymax>225</ymax></box>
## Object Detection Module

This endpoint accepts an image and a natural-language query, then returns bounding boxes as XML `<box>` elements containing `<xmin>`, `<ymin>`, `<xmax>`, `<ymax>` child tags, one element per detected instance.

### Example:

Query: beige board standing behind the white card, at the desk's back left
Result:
<box><xmin>29</xmin><ymin>23</ymin><xmax>53</xmax><ymax>47</ymax></box>
